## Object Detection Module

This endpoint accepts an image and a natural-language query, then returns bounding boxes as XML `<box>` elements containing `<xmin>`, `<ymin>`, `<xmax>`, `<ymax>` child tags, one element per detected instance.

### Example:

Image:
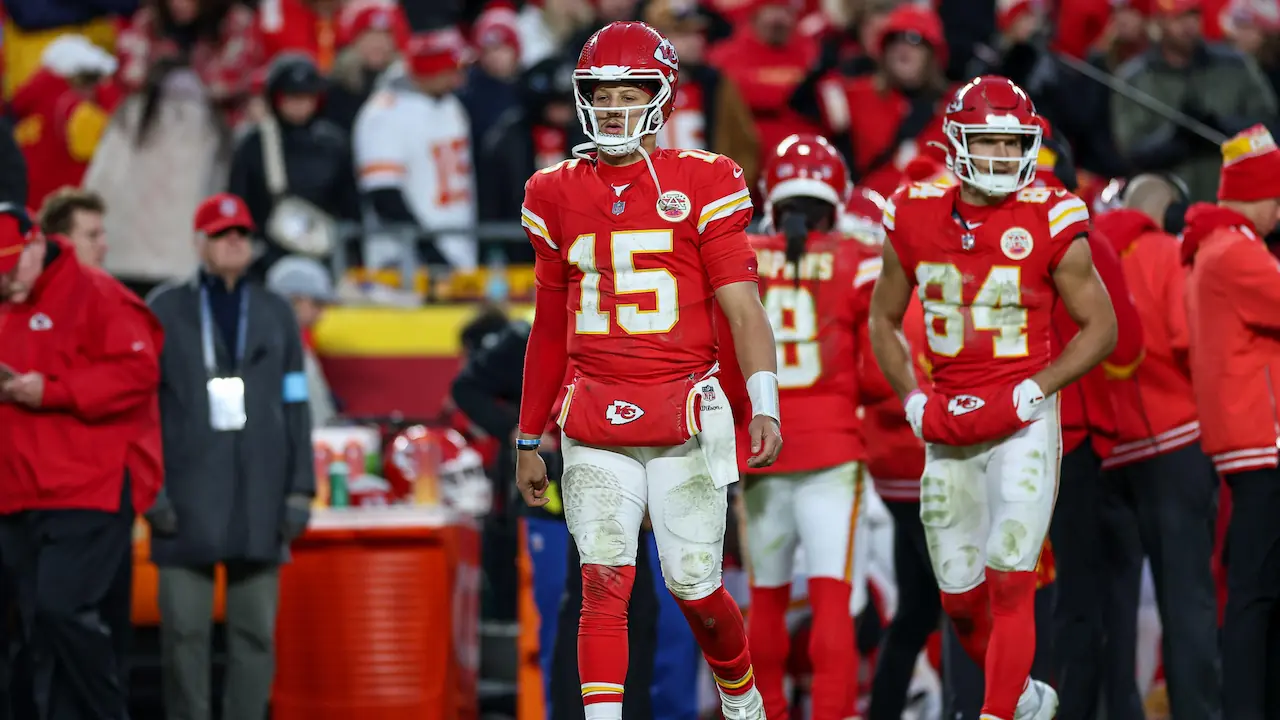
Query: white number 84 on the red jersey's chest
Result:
<box><xmin>915</xmin><ymin>263</ymin><xmax>1028</xmax><ymax>357</ymax></box>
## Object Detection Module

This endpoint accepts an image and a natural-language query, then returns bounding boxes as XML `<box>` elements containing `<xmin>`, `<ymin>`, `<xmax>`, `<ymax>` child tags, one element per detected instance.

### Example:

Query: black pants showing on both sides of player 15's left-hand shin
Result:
<box><xmin>550</xmin><ymin>527</ymin><xmax>666</xmax><ymax>720</ymax></box>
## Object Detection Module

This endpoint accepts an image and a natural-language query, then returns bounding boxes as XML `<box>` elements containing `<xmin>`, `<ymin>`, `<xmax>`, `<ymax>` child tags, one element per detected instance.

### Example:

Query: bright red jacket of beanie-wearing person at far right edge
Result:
<box><xmin>1183</xmin><ymin>204</ymin><xmax>1280</xmax><ymax>474</ymax></box>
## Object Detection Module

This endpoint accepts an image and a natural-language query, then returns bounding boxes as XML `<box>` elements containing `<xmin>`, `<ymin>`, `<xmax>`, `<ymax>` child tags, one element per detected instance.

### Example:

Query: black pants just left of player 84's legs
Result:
<box><xmin>868</xmin><ymin>502</ymin><xmax>942</xmax><ymax>720</ymax></box>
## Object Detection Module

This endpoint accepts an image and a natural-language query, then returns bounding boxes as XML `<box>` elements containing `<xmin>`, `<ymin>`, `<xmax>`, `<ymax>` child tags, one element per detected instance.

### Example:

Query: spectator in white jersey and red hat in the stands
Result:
<box><xmin>355</xmin><ymin>31</ymin><xmax>477</xmax><ymax>270</ymax></box>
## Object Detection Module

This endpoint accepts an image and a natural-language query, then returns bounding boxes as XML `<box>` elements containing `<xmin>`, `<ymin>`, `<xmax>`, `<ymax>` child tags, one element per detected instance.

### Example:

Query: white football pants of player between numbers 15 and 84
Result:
<box><xmin>744</xmin><ymin>462</ymin><xmax>863</xmax><ymax>588</ymax></box>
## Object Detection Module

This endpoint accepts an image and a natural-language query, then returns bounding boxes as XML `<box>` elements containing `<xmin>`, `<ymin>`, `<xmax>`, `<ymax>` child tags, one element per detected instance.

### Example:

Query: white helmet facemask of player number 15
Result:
<box><xmin>573</xmin><ymin>65</ymin><xmax>672</xmax><ymax>158</ymax></box>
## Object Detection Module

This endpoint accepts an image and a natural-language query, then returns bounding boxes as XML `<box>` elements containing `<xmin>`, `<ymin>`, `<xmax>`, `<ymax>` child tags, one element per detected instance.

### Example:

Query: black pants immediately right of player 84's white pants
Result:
<box><xmin>1050</xmin><ymin>439</ymin><xmax>1111</xmax><ymax>720</ymax></box>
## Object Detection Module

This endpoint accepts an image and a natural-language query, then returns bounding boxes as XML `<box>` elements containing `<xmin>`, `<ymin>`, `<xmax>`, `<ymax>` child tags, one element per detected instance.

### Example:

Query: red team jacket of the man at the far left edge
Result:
<box><xmin>0</xmin><ymin>237</ymin><xmax>164</xmax><ymax>514</ymax></box>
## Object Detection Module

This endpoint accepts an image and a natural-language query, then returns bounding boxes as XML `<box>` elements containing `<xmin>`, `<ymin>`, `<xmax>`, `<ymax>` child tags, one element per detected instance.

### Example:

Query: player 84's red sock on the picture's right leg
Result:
<box><xmin>982</xmin><ymin>568</ymin><xmax>1036</xmax><ymax>720</ymax></box>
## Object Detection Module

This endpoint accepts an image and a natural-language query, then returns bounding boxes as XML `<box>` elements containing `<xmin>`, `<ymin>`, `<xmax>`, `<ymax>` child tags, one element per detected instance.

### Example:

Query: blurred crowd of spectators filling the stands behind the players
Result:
<box><xmin>3</xmin><ymin>0</ymin><xmax>1280</xmax><ymax>304</ymax></box>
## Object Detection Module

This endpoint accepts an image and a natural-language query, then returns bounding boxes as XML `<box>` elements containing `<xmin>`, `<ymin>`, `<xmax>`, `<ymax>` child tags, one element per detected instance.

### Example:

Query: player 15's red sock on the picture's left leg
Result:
<box><xmin>577</xmin><ymin>565</ymin><xmax>636</xmax><ymax>719</ymax></box>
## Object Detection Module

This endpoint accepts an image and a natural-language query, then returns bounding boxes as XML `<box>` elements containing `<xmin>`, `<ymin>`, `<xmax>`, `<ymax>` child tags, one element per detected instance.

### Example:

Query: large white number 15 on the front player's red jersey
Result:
<box><xmin>568</xmin><ymin>231</ymin><xmax>680</xmax><ymax>334</ymax></box>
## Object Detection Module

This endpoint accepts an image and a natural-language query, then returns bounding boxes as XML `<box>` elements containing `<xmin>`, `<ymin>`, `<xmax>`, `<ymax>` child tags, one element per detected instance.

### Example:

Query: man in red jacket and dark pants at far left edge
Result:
<box><xmin>0</xmin><ymin>205</ymin><xmax>163</xmax><ymax>719</ymax></box>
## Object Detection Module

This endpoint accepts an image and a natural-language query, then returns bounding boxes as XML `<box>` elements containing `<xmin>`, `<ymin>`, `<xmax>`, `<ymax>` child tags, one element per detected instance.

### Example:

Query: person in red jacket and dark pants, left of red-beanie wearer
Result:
<box><xmin>1093</xmin><ymin>176</ymin><xmax>1222</xmax><ymax>717</ymax></box>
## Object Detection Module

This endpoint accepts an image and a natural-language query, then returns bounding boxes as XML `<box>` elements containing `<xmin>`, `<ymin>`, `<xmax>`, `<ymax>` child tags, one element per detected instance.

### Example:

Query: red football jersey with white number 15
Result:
<box><xmin>521</xmin><ymin>150</ymin><xmax>756</xmax><ymax>383</ymax></box>
